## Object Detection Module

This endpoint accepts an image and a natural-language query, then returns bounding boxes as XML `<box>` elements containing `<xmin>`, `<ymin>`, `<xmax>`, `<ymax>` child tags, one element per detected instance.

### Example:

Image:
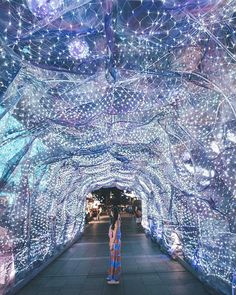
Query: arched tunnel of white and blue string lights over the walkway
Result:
<box><xmin>0</xmin><ymin>0</ymin><xmax>236</xmax><ymax>294</ymax></box>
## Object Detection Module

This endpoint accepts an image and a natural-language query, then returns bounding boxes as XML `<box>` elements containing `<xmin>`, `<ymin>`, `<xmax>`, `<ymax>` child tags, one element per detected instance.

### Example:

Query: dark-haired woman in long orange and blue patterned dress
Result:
<box><xmin>107</xmin><ymin>207</ymin><xmax>121</xmax><ymax>284</ymax></box>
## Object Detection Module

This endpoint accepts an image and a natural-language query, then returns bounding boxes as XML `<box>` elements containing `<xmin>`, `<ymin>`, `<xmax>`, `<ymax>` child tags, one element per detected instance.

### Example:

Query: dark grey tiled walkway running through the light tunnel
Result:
<box><xmin>18</xmin><ymin>216</ymin><xmax>214</xmax><ymax>295</ymax></box>
